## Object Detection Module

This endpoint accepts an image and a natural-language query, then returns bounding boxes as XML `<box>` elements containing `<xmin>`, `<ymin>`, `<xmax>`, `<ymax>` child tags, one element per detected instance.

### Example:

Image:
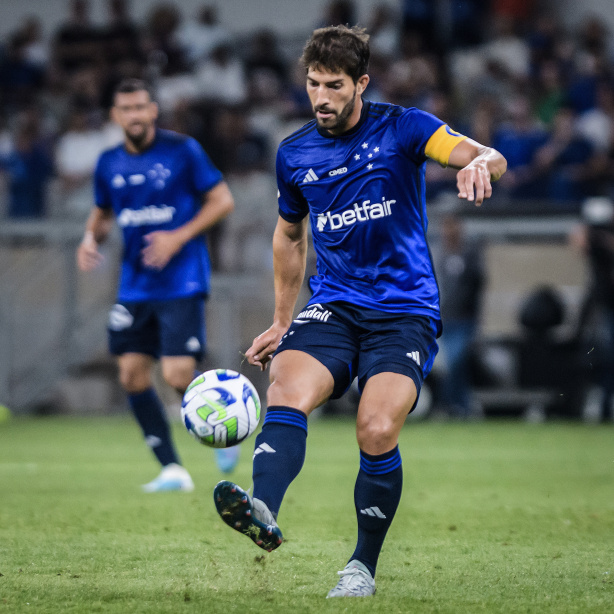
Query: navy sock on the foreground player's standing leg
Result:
<box><xmin>350</xmin><ymin>446</ymin><xmax>403</xmax><ymax>577</ymax></box>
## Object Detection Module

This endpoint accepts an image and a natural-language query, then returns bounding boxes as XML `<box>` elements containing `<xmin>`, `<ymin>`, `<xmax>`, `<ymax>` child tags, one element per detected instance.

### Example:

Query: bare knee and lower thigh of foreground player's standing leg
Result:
<box><xmin>356</xmin><ymin>372</ymin><xmax>418</xmax><ymax>454</ymax></box>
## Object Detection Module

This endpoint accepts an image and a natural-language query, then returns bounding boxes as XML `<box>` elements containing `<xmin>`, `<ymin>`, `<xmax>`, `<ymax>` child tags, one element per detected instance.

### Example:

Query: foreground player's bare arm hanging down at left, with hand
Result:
<box><xmin>245</xmin><ymin>216</ymin><xmax>308</xmax><ymax>371</ymax></box>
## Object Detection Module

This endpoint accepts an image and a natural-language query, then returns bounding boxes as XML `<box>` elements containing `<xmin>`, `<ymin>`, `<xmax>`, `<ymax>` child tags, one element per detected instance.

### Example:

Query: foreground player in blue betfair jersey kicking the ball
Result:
<box><xmin>214</xmin><ymin>26</ymin><xmax>506</xmax><ymax>597</ymax></box>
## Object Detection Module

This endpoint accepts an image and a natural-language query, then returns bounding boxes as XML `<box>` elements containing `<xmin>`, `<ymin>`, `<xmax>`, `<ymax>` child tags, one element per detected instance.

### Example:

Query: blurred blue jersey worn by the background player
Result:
<box><xmin>95</xmin><ymin>130</ymin><xmax>222</xmax><ymax>301</ymax></box>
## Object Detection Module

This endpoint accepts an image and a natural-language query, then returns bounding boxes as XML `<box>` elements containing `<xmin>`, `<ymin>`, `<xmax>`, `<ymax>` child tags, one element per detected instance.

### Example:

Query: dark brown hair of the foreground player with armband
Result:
<box><xmin>301</xmin><ymin>26</ymin><xmax>371</xmax><ymax>83</ymax></box>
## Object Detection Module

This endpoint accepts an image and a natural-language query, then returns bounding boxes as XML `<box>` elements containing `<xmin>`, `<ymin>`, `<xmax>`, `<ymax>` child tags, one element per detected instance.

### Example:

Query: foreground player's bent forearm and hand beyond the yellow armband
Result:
<box><xmin>448</xmin><ymin>139</ymin><xmax>507</xmax><ymax>207</ymax></box>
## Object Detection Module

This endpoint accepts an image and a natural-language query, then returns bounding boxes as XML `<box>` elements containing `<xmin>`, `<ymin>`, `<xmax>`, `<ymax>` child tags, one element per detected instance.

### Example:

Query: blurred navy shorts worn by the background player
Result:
<box><xmin>108</xmin><ymin>296</ymin><xmax>205</xmax><ymax>360</ymax></box>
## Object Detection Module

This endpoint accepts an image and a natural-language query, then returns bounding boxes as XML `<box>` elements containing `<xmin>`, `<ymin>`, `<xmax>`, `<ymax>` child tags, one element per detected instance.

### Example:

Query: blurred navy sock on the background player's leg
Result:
<box><xmin>128</xmin><ymin>388</ymin><xmax>179</xmax><ymax>466</ymax></box>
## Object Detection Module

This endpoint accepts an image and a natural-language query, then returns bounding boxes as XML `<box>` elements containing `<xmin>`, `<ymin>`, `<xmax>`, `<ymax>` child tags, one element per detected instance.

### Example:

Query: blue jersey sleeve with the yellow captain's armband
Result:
<box><xmin>399</xmin><ymin>109</ymin><xmax>467</xmax><ymax>166</ymax></box>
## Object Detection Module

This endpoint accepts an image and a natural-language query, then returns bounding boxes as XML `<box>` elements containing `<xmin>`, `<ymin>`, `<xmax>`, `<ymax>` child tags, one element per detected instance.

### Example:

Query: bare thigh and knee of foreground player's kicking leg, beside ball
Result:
<box><xmin>267</xmin><ymin>350</ymin><xmax>335</xmax><ymax>415</ymax></box>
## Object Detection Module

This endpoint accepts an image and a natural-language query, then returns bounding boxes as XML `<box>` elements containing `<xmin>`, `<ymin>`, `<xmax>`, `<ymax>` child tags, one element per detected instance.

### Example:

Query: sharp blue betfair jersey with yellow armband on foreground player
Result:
<box><xmin>277</xmin><ymin>101</ymin><xmax>465</xmax><ymax>332</ymax></box>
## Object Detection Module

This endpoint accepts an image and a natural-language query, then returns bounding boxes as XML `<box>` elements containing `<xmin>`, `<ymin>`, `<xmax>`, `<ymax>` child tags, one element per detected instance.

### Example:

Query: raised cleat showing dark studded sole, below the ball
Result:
<box><xmin>213</xmin><ymin>480</ymin><xmax>283</xmax><ymax>552</ymax></box>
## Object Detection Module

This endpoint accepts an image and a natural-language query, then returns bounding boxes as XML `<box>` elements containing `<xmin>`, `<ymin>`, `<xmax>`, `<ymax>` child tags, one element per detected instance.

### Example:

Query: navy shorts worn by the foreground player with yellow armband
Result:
<box><xmin>275</xmin><ymin>302</ymin><xmax>439</xmax><ymax>399</ymax></box>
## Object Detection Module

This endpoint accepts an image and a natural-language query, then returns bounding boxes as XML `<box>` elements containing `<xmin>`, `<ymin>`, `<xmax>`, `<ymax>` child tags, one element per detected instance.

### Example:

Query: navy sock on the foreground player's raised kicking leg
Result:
<box><xmin>252</xmin><ymin>405</ymin><xmax>307</xmax><ymax>518</ymax></box>
